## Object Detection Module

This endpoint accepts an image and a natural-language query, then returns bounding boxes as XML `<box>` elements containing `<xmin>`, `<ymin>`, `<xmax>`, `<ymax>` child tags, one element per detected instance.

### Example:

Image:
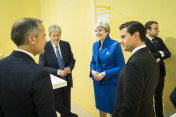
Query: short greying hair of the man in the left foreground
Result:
<box><xmin>11</xmin><ymin>18</ymin><xmax>42</xmax><ymax>46</ymax></box>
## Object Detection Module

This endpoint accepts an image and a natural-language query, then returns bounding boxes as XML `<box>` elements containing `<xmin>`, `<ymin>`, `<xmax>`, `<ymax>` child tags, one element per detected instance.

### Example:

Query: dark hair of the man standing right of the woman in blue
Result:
<box><xmin>119</xmin><ymin>21</ymin><xmax>146</xmax><ymax>42</ymax></box>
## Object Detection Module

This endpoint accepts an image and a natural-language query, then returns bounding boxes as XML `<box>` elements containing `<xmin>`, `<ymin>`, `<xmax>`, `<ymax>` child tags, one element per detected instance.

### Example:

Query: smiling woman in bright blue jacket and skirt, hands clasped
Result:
<box><xmin>90</xmin><ymin>22</ymin><xmax>125</xmax><ymax>117</ymax></box>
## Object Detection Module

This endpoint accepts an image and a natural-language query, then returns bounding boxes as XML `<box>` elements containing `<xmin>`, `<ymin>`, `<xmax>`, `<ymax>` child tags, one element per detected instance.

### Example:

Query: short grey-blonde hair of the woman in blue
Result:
<box><xmin>95</xmin><ymin>21</ymin><xmax>110</xmax><ymax>34</ymax></box>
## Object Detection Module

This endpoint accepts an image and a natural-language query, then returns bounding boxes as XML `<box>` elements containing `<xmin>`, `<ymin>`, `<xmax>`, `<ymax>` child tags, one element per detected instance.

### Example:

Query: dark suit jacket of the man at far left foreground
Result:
<box><xmin>0</xmin><ymin>51</ymin><xmax>56</xmax><ymax>117</ymax></box>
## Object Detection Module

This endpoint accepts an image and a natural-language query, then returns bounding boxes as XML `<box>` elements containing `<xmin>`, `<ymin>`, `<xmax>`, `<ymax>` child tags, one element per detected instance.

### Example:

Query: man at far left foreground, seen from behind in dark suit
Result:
<box><xmin>0</xmin><ymin>18</ymin><xmax>57</xmax><ymax>117</ymax></box>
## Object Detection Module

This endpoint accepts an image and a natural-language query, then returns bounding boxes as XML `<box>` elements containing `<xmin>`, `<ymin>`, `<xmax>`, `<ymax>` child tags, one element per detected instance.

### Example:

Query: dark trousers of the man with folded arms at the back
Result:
<box><xmin>154</xmin><ymin>75</ymin><xmax>164</xmax><ymax>117</ymax></box>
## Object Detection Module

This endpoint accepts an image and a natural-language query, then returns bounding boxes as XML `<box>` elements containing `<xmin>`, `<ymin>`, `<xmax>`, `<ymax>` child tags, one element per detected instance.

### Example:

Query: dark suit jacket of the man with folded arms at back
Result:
<box><xmin>145</xmin><ymin>37</ymin><xmax>171</xmax><ymax>76</ymax></box>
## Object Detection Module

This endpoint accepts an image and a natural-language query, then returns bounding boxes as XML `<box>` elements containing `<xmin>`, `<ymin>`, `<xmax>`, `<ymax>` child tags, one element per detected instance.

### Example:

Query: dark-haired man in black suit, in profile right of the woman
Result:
<box><xmin>113</xmin><ymin>21</ymin><xmax>159</xmax><ymax>117</ymax></box>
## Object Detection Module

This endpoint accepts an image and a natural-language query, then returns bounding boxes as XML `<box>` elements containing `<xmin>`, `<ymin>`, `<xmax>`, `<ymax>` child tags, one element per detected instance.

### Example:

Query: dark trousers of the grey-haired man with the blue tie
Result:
<box><xmin>54</xmin><ymin>86</ymin><xmax>72</xmax><ymax>117</ymax></box>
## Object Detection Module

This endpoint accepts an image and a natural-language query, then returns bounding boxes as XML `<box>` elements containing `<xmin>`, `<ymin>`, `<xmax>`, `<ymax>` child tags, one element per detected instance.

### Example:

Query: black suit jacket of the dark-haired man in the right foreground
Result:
<box><xmin>113</xmin><ymin>47</ymin><xmax>159</xmax><ymax>117</ymax></box>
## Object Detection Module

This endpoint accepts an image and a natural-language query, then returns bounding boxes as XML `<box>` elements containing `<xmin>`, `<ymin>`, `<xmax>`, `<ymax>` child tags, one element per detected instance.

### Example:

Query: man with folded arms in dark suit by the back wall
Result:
<box><xmin>145</xmin><ymin>21</ymin><xmax>171</xmax><ymax>117</ymax></box>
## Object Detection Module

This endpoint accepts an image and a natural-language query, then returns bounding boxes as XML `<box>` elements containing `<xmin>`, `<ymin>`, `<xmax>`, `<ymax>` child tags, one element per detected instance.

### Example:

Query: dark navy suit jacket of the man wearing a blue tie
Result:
<box><xmin>39</xmin><ymin>40</ymin><xmax>75</xmax><ymax>87</ymax></box>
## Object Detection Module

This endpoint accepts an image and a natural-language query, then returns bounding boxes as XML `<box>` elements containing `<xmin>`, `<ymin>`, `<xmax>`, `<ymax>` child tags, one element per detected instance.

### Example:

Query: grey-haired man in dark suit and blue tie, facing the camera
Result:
<box><xmin>39</xmin><ymin>24</ymin><xmax>77</xmax><ymax>117</ymax></box>
